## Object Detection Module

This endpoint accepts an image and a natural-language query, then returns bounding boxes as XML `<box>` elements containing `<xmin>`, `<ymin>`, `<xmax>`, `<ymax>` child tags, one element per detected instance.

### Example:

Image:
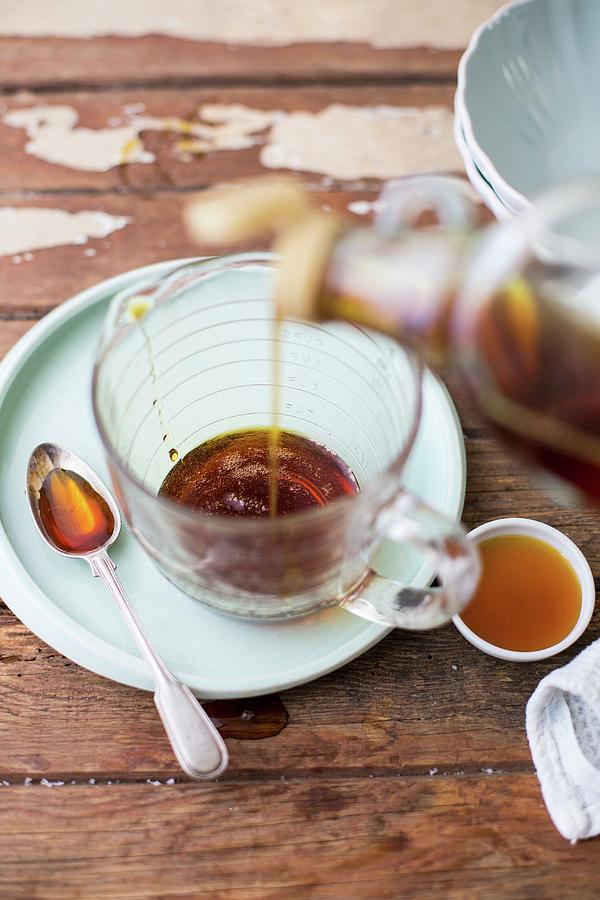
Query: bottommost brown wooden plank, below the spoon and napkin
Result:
<box><xmin>0</xmin><ymin>775</ymin><xmax>598</xmax><ymax>900</ymax></box>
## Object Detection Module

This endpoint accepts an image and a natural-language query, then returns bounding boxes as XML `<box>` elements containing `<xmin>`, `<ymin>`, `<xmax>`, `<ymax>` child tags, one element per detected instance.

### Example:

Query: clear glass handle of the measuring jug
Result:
<box><xmin>340</xmin><ymin>492</ymin><xmax>480</xmax><ymax>631</ymax></box>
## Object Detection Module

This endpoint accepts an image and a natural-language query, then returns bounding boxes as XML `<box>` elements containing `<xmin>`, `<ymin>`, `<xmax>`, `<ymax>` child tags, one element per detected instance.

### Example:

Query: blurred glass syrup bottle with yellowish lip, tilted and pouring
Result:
<box><xmin>188</xmin><ymin>176</ymin><xmax>600</xmax><ymax>500</ymax></box>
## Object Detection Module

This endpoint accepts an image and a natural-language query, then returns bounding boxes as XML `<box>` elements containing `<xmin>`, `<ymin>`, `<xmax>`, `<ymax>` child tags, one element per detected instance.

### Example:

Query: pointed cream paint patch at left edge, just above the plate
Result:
<box><xmin>0</xmin><ymin>206</ymin><xmax>132</xmax><ymax>263</ymax></box>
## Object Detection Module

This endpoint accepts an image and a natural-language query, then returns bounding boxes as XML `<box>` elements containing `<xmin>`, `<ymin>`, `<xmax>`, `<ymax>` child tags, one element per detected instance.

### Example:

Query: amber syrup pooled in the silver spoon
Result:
<box><xmin>39</xmin><ymin>468</ymin><xmax>115</xmax><ymax>553</ymax></box>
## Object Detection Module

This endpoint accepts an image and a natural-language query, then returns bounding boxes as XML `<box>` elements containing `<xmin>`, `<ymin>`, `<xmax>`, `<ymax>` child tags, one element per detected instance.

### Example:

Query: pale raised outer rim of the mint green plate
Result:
<box><xmin>0</xmin><ymin>258</ymin><xmax>466</xmax><ymax>698</ymax></box>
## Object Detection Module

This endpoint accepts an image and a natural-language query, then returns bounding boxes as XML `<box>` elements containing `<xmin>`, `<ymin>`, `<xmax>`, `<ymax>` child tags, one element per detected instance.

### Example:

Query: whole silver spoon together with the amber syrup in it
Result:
<box><xmin>27</xmin><ymin>444</ymin><xmax>229</xmax><ymax>780</ymax></box>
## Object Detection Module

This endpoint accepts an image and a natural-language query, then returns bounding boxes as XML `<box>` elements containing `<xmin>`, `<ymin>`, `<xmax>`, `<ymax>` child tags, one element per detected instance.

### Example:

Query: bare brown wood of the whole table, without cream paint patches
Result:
<box><xmin>0</xmin><ymin>8</ymin><xmax>600</xmax><ymax>900</ymax></box>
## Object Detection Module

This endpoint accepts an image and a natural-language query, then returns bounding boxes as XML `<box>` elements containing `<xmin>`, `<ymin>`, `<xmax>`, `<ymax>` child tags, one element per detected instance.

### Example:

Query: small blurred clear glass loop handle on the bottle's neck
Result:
<box><xmin>374</xmin><ymin>175</ymin><xmax>475</xmax><ymax>238</ymax></box>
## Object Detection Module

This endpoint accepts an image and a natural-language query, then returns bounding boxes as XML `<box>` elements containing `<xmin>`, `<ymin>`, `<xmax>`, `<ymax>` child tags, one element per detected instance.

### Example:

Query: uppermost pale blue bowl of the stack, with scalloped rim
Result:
<box><xmin>455</xmin><ymin>0</ymin><xmax>600</xmax><ymax>209</ymax></box>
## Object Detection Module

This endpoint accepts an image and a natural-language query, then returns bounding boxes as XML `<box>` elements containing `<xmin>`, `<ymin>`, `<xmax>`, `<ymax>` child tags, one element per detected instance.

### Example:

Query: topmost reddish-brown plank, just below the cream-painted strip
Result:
<box><xmin>0</xmin><ymin>35</ymin><xmax>461</xmax><ymax>90</ymax></box>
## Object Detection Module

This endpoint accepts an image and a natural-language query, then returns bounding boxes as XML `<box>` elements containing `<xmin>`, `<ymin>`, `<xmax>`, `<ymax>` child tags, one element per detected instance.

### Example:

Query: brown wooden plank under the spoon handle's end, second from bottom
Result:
<box><xmin>0</xmin><ymin>614</ymin><xmax>600</xmax><ymax>780</ymax></box>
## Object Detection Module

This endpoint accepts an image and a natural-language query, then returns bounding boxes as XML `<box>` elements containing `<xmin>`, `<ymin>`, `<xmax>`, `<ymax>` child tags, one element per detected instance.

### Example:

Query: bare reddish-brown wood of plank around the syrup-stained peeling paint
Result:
<box><xmin>0</xmin><ymin>84</ymin><xmax>454</xmax><ymax>193</ymax></box>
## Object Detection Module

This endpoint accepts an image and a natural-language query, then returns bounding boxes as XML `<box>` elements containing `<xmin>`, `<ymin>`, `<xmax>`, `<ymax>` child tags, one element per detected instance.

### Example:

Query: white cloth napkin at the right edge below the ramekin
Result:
<box><xmin>526</xmin><ymin>640</ymin><xmax>600</xmax><ymax>843</ymax></box>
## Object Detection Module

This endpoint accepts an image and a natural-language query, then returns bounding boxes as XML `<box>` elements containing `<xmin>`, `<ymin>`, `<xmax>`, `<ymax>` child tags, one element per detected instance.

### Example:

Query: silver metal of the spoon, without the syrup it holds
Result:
<box><xmin>27</xmin><ymin>444</ymin><xmax>229</xmax><ymax>780</ymax></box>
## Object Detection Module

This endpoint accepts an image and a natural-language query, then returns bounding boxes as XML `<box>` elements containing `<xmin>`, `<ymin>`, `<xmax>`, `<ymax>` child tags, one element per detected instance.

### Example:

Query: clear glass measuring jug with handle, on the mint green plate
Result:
<box><xmin>93</xmin><ymin>254</ymin><xmax>478</xmax><ymax>628</ymax></box>
